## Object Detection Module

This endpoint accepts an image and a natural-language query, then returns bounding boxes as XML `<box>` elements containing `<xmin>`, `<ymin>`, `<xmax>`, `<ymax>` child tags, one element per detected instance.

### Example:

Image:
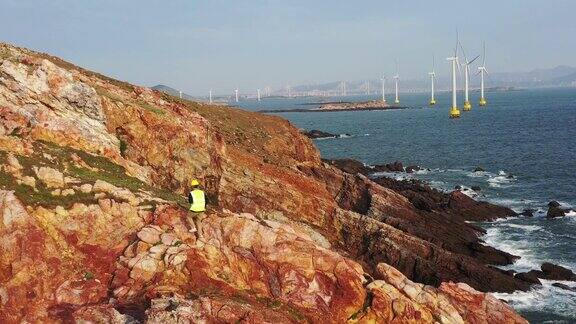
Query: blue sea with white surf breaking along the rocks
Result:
<box><xmin>237</xmin><ymin>88</ymin><xmax>576</xmax><ymax>323</ymax></box>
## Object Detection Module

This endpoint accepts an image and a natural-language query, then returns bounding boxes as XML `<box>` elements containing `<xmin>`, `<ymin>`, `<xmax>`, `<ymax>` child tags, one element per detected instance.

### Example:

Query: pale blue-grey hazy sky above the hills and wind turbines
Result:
<box><xmin>0</xmin><ymin>0</ymin><xmax>576</xmax><ymax>95</ymax></box>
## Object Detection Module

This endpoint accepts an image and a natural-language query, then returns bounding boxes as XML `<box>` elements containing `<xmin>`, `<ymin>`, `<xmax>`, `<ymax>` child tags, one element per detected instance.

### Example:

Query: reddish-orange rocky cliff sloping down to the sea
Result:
<box><xmin>0</xmin><ymin>44</ymin><xmax>529</xmax><ymax>323</ymax></box>
